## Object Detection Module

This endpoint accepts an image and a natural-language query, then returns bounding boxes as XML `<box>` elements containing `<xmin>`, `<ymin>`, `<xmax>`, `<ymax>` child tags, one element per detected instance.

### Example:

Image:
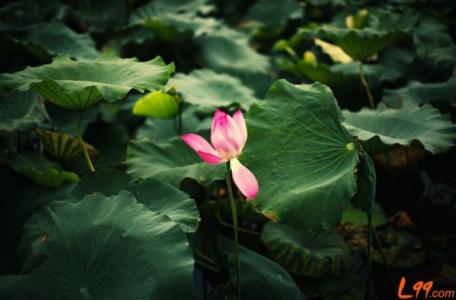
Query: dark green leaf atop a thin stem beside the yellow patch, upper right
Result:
<box><xmin>315</xmin><ymin>26</ymin><xmax>399</xmax><ymax>60</ymax></box>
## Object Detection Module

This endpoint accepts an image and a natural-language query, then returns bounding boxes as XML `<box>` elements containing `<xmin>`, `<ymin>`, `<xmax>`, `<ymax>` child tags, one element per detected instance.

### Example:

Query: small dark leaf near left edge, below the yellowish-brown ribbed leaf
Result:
<box><xmin>8</xmin><ymin>154</ymin><xmax>79</xmax><ymax>186</ymax></box>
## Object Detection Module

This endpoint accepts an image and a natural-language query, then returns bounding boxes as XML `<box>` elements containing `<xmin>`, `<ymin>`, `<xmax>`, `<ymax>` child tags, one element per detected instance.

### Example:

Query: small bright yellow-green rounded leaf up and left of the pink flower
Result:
<box><xmin>133</xmin><ymin>91</ymin><xmax>178</xmax><ymax>119</ymax></box>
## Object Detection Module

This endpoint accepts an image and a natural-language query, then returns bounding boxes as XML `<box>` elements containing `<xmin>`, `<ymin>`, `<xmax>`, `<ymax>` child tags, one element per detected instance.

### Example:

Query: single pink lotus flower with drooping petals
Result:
<box><xmin>181</xmin><ymin>110</ymin><xmax>258</xmax><ymax>200</ymax></box>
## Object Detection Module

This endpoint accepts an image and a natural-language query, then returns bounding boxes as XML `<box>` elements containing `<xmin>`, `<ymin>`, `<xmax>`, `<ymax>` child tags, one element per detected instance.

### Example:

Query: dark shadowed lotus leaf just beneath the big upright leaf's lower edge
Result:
<box><xmin>261</xmin><ymin>222</ymin><xmax>350</xmax><ymax>277</ymax></box>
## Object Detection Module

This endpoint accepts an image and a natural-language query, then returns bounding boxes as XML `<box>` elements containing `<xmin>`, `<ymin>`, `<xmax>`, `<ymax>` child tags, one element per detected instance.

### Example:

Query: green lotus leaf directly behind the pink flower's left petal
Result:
<box><xmin>127</xmin><ymin>137</ymin><xmax>224</xmax><ymax>186</ymax></box>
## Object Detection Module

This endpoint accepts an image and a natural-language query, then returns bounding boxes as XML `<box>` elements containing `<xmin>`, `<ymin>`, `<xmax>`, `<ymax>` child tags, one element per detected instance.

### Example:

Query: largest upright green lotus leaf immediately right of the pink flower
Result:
<box><xmin>241</xmin><ymin>80</ymin><xmax>358</xmax><ymax>230</ymax></box>
